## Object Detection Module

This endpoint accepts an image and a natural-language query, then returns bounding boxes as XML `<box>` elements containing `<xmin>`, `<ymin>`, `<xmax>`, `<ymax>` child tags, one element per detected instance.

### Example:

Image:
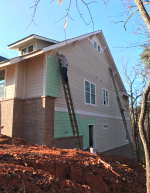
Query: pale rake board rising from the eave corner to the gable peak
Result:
<box><xmin>43</xmin><ymin>30</ymin><xmax>101</xmax><ymax>52</ymax></box>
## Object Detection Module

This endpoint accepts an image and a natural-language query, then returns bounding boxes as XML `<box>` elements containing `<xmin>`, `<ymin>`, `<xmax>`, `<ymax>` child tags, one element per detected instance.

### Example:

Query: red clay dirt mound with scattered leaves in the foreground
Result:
<box><xmin>0</xmin><ymin>135</ymin><xmax>146</xmax><ymax>193</ymax></box>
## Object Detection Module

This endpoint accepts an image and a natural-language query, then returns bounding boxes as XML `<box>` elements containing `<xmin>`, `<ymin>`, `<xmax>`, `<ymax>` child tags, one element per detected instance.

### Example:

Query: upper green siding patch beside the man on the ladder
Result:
<box><xmin>46</xmin><ymin>55</ymin><xmax>60</xmax><ymax>97</ymax></box>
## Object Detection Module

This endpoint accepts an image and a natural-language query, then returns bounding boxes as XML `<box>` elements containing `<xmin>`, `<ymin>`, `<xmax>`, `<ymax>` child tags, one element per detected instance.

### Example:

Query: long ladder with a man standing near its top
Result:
<box><xmin>59</xmin><ymin>62</ymin><xmax>81</xmax><ymax>149</ymax></box>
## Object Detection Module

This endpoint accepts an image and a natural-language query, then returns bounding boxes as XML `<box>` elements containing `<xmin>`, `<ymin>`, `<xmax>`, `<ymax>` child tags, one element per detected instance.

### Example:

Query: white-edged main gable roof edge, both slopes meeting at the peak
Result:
<box><xmin>0</xmin><ymin>30</ymin><xmax>126</xmax><ymax>92</ymax></box>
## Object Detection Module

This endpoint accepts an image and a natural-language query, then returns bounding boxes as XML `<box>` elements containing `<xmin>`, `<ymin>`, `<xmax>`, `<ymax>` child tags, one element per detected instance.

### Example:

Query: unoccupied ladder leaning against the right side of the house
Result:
<box><xmin>109</xmin><ymin>68</ymin><xmax>134</xmax><ymax>155</ymax></box>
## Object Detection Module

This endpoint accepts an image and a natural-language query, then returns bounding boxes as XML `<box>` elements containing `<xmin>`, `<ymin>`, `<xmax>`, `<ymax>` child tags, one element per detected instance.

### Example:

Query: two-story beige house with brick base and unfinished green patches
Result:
<box><xmin>0</xmin><ymin>30</ymin><xmax>131</xmax><ymax>158</ymax></box>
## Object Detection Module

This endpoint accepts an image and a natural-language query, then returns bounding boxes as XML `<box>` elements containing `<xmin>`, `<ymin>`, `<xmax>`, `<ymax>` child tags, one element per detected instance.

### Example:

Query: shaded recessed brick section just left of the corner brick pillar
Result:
<box><xmin>21</xmin><ymin>98</ymin><xmax>45</xmax><ymax>145</ymax></box>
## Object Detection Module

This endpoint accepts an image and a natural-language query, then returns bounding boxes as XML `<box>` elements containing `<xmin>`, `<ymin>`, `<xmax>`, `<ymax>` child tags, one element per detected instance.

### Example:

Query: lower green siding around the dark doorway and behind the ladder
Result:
<box><xmin>54</xmin><ymin>111</ymin><xmax>95</xmax><ymax>148</ymax></box>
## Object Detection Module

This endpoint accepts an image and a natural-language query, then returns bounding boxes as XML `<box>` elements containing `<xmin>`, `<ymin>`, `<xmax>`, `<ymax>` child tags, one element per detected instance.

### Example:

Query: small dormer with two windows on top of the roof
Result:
<box><xmin>7</xmin><ymin>34</ymin><xmax>59</xmax><ymax>56</ymax></box>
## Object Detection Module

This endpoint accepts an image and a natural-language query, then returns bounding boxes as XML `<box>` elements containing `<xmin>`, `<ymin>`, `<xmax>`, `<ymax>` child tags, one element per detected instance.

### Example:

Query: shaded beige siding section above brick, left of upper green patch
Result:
<box><xmin>25</xmin><ymin>55</ymin><xmax>44</xmax><ymax>98</ymax></box>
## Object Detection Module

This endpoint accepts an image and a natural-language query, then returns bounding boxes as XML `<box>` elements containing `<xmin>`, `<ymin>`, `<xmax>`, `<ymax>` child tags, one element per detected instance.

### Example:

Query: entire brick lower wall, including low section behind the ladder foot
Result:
<box><xmin>0</xmin><ymin>97</ymin><xmax>83</xmax><ymax>149</ymax></box>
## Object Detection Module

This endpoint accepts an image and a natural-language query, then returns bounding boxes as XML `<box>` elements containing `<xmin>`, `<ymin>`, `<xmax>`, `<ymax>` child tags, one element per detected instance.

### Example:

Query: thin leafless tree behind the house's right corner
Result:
<box><xmin>121</xmin><ymin>57</ymin><xmax>144</xmax><ymax>161</ymax></box>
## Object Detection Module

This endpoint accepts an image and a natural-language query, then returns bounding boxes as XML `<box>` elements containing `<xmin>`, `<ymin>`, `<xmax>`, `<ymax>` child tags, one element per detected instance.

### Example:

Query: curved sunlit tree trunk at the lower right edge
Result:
<box><xmin>139</xmin><ymin>79</ymin><xmax>150</xmax><ymax>193</ymax></box>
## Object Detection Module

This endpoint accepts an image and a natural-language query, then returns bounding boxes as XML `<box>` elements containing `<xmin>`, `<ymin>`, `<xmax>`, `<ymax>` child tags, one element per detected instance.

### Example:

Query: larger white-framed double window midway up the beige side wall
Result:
<box><xmin>85</xmin><ymin>81</ymin><xmax>96</xmax><ymax>105</ymax></box>
